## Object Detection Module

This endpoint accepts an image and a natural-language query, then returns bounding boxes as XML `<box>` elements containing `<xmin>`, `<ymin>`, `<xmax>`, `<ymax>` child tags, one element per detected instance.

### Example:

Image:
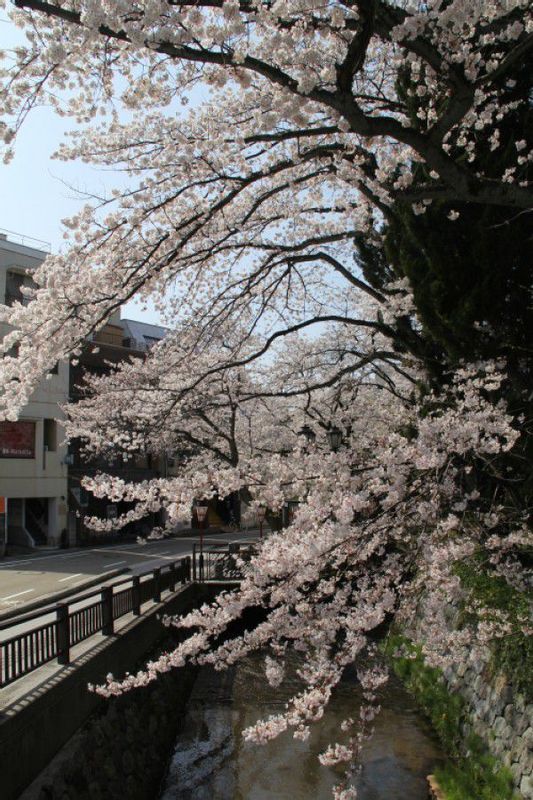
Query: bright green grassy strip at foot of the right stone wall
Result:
<box><xmin>384</xmin><ymin>634</ymin><xmax>516</xmax><ymax>800</ymax></box>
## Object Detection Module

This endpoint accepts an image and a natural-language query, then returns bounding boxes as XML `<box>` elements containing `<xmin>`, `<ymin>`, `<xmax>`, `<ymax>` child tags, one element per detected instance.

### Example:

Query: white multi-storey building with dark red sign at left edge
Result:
<box><xmin>0</xmin><ymin>228</ymin><xmax>69</xmax><ymax>546</ymax></box>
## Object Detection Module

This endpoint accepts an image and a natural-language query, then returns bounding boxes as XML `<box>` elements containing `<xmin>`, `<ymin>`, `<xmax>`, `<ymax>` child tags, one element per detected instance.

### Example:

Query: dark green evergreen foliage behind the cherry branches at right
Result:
<box><xmin>355</xmin><ymin>50</ymin><xmax>533</xmax><ymax>505</ymax></box>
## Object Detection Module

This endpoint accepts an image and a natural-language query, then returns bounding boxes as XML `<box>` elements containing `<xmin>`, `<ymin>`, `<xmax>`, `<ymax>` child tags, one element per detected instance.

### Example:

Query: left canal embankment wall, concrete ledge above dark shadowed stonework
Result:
<box><xmin>0</xmin><ymin>584</ymin><xmax>227</xmax><ymax>800</ymax></box>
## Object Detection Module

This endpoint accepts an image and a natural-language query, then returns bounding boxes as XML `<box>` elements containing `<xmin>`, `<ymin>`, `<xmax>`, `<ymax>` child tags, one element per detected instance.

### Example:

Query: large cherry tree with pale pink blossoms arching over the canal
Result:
<box><xmin>0</xmin><ymin>0</ymin><xmax>533</xmax><ymax>798</ymax></box>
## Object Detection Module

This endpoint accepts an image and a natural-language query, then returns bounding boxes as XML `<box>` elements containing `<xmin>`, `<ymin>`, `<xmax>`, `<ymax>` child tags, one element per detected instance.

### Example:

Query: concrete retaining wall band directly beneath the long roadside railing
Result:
<box><xmin>0</xmin><ymin>584</ymin><xmax>229</xmax><ymax>800</ymax></box>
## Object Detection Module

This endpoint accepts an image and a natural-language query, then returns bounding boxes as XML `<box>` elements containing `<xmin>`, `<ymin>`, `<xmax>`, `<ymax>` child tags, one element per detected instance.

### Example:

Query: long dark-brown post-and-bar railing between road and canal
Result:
<box><xmin>0</xmin><ymin>556</ymin><xmax>191</xmax><ymax>688</ymax></box>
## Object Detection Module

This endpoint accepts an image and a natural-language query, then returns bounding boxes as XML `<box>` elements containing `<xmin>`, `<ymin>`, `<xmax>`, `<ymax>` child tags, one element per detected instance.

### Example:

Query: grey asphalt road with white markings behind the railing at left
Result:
<box><xmin>0</xmin><ymin>531</ymin><xmax>255</xmax><ymax>614</ymax></box>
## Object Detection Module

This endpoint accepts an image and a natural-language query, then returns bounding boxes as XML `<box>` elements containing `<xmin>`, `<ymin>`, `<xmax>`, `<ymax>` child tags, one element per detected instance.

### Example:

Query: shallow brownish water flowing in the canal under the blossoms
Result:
<box><xmin>161</xmin><ymin>655</ymin><xmax>442</xmax><ymax>800</ymax></box>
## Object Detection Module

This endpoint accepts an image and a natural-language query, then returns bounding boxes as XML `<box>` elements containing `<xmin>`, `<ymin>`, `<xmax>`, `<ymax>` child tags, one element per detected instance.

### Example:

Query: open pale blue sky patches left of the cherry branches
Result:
<box><xmin>0</xmin><ymin>12</ymin><xmax>159</xmax><ymax>322</ymax></box>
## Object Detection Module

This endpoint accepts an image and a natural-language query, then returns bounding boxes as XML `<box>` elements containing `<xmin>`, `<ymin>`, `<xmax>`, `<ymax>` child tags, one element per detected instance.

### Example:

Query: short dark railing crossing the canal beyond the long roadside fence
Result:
<box><xmin>192</xmin><ymin>541</ymin><xmax>257</xmax><ymax>583</ymax></box>
